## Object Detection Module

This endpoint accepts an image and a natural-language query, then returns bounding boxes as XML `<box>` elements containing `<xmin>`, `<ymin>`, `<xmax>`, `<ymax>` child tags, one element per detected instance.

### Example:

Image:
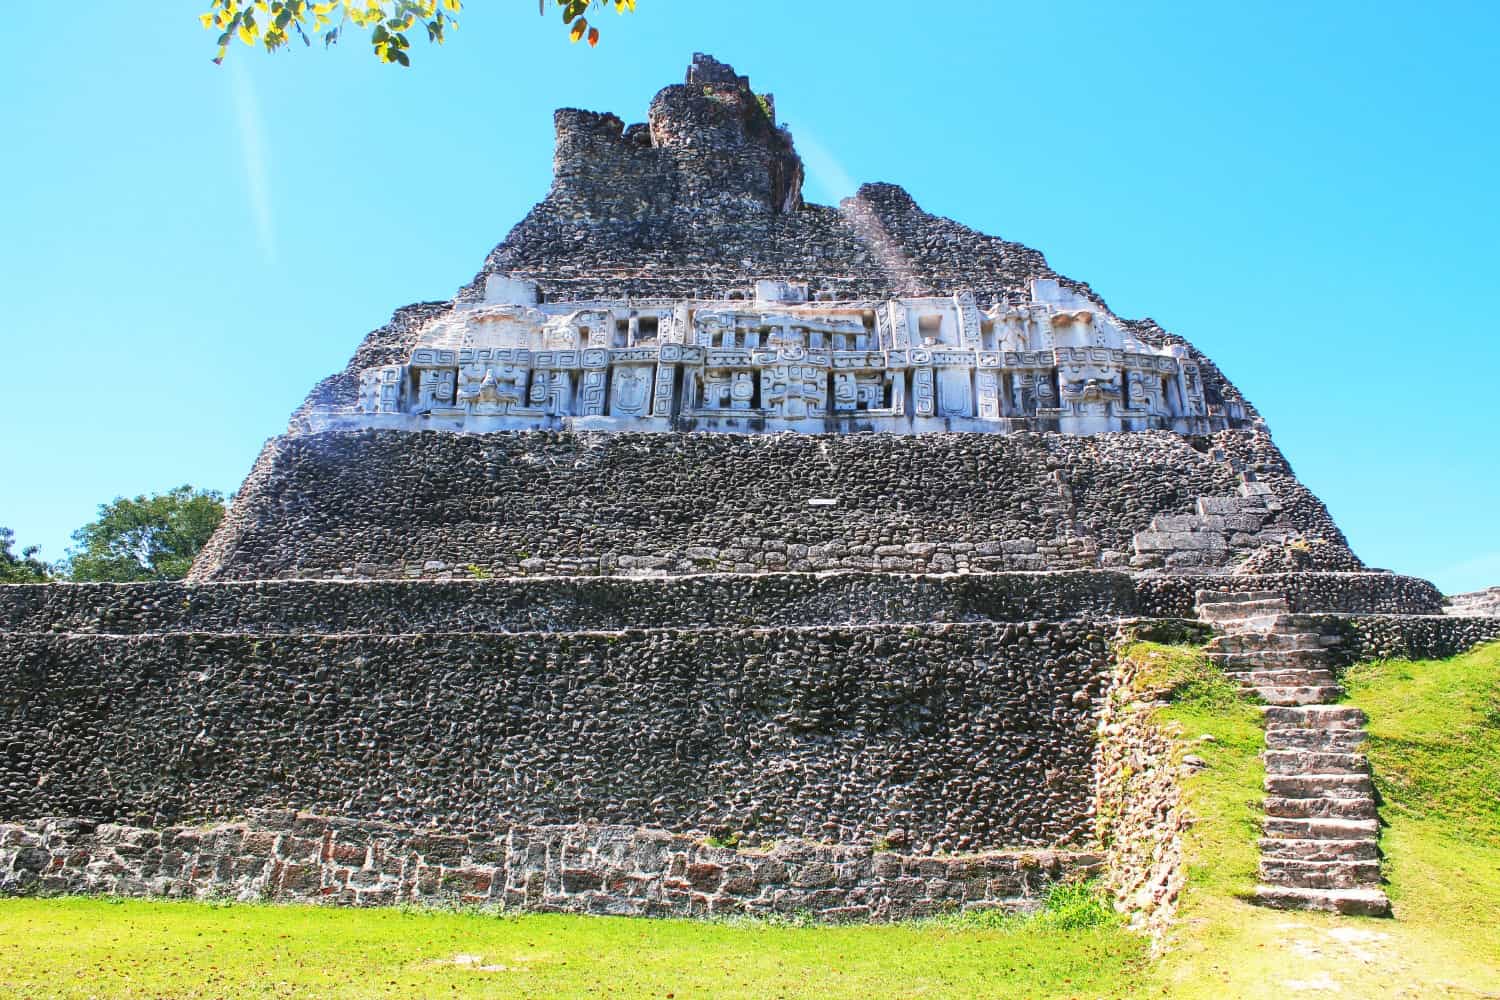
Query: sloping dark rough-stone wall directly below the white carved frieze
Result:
<box><xmin>192</xmin><ymin>430</ymin><xmax>1358</xmax><ymax>580</ymax></box>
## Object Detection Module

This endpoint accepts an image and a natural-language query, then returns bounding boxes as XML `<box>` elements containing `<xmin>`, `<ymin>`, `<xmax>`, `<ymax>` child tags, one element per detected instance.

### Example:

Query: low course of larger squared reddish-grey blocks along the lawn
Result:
<box><xmin>0</xmin><ymin>811</ymin><xmax>1100</xmax><ymax>921</ymax></box>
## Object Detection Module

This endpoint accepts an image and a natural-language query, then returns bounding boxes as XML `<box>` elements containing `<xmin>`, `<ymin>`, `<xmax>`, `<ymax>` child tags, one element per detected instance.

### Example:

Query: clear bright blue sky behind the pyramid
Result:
<box><xmin>0</xmin><ymin>0</ymin><xmax>1500</xmax><ymax>592</ymax></box>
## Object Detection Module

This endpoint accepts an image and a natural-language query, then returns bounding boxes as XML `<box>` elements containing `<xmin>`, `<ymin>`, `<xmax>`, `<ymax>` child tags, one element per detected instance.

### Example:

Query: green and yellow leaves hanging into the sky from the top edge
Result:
<box><xmin>198</xmin><ymin>0</ymin><xmax>636</xmax><ymax>66</ymax></box>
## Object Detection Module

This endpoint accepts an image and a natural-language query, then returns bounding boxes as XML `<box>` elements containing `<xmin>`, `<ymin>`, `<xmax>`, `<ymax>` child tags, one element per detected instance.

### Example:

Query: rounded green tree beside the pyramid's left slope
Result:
<box><xmin>66</xmin><ymin>486</ymin><xmax>225</xmax><ymax>583</ymax></box>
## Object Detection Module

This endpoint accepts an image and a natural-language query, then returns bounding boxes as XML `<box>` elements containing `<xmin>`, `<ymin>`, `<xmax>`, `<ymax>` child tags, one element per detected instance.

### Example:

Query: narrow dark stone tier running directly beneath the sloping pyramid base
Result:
<box><xmin>0</xmin><ymin>570</ymin><xmax>1442</xmax><ymax>636</ymax></box>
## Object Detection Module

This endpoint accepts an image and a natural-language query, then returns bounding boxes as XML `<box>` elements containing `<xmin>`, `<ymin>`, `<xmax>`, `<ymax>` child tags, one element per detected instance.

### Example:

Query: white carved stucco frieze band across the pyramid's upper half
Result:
<box><xmin>322</xmin><ymin>280</ymin><xmax>1245</xmax><ymax>433</ymax></box>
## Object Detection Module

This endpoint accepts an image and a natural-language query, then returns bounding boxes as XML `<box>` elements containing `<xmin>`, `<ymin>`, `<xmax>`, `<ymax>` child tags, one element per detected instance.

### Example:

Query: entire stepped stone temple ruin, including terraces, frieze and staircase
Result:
<box><xmin>0</xmin><ymin>55</ymin><xmax>1500</xmax><ymax>921</ymax></box>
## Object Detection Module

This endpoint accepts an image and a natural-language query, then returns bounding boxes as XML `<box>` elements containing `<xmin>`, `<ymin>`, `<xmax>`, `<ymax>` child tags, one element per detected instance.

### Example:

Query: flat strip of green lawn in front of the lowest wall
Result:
<box><xmin>0</xmin><ymin>900</ymin><xmax>1145</xmax><ymax>1000</ymax></box>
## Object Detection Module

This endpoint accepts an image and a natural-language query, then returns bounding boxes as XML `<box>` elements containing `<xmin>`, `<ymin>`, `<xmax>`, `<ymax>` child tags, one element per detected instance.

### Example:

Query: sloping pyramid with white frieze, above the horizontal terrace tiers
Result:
<box><xmin>194</xmin><ymin>55</ymin><xmax>1361</xmax><ymax>580</ymax></box>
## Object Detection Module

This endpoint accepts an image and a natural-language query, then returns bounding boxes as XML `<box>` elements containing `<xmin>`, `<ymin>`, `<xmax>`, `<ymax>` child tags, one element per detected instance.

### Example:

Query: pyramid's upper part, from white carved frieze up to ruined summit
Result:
<box><xmin>319</xmin><ymin>55</ymin><xmax>1254</xmax><ymax>435</ymax></box>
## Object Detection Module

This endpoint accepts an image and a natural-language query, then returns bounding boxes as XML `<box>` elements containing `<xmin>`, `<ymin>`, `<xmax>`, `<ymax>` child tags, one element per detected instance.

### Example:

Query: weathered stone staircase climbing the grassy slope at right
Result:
<box><xmin>1197</xmin><ymin>591</ymin><xmax>1391</xmax><ymax>916</ymax></box>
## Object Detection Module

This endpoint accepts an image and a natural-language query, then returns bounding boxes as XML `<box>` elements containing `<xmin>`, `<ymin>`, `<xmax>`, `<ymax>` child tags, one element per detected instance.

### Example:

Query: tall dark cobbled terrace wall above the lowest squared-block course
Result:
<box><xmin>0</xmin><ymin>622</ymin><xmax>1110</xmax><ymax>853</ymax></box>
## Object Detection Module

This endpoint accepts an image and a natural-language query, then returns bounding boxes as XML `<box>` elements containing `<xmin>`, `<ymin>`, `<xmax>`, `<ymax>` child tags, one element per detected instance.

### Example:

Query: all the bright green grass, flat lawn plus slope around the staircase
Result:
<box><xmin>0</xmin><ymin>643</ymin><xmax>1500</xmax><ymax>1000</ymax></box>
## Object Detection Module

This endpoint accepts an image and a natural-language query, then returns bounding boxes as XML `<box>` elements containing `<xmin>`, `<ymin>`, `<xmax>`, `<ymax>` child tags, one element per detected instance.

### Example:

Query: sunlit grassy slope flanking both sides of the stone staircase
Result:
<box><xmin>1152</xmin><ymin>645</ymin><xmax>1500</xmax><ymax>1000</ymax></box>
